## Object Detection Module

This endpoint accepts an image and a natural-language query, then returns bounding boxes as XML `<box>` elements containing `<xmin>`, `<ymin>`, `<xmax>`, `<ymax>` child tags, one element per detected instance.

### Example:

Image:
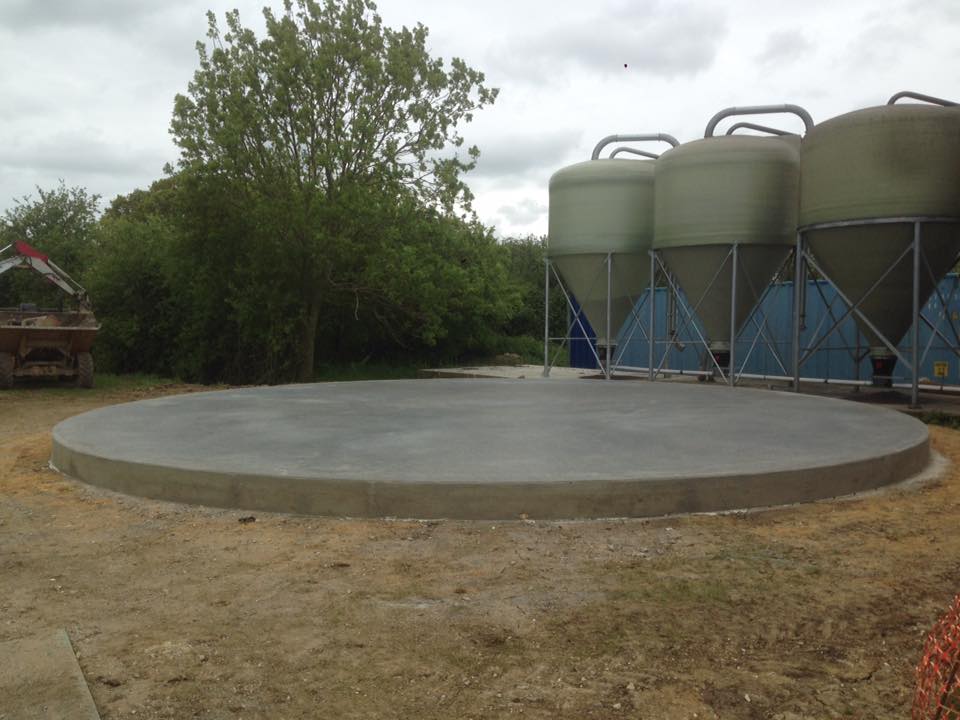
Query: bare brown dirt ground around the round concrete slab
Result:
<box><xmin>0</xmin><ymin>386</ymin><xmax>960</xmax><ymax>720</ymax></box>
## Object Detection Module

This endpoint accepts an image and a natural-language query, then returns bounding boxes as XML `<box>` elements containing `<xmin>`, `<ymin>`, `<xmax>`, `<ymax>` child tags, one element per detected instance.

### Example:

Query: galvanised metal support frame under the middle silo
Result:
<box><xmin>647</xmin><ymin>243</ymin><xmax>793</xmax><ymax>387</ymax></box>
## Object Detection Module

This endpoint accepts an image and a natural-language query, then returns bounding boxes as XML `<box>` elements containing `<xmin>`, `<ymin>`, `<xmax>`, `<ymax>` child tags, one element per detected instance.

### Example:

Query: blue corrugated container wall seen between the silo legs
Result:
<box><xmin>570</xmin><ymin>274</ymin><xmax>960</xmax><ymax>385</ymax></box>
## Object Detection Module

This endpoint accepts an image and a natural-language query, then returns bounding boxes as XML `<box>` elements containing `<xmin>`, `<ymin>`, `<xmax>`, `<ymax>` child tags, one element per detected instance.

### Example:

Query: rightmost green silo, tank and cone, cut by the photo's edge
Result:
<box><xmin>800</xmin><ymin>96</ymin><xmax>960</xmax><ymax>385</ymax></box>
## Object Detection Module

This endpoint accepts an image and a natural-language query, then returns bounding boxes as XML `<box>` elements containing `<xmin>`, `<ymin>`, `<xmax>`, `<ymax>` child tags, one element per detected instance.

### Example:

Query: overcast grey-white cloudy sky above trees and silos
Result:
<box><xmin>0</xmin><ymin>0</ymin><xmax>960</xmax><ymax>236</ymax></box>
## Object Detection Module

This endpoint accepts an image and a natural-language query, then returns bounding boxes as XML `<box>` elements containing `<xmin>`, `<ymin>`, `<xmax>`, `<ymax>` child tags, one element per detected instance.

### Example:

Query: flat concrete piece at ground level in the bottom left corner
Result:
<box><xmin>0</xmin><ymin>630</ymin><xmax>100</xmax><ymax>720</ymax></box>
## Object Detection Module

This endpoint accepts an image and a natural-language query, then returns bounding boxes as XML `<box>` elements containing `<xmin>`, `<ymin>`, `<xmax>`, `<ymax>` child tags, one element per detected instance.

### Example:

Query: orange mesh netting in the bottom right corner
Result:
<box><xmin>911</xmin><ymin>595</ymin><xmax>960</xmax><ymax>720</ymax></box>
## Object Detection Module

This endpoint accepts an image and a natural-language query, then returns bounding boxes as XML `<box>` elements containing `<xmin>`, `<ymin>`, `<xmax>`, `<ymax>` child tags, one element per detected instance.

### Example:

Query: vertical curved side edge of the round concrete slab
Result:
<box><xmin>51</xmin><ymin>435</ymin><xmax>930</xmax><ymax>520</ymax></box>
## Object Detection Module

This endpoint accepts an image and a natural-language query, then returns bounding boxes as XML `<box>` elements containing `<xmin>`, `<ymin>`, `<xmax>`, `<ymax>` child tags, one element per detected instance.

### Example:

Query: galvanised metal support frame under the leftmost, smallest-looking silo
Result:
<box><xmin>543</xmin><ymin>252</ymin><xmax>653</xmax><ymax>380</ymax></box>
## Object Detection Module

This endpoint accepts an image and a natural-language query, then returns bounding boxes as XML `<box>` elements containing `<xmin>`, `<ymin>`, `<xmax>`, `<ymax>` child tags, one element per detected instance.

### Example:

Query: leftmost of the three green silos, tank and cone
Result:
<box><xmin>547</xmin><ymin>159</ymin><xmax>654</xmax><ymax>347</ymax></box>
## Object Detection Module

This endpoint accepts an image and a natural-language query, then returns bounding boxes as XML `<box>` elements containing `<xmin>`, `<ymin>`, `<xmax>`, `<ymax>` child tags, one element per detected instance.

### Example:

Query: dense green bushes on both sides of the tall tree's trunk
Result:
<box><xmin>0</xmin><ymin>179</ymin><xmax>563</xmax><ymax>383</ymax></box>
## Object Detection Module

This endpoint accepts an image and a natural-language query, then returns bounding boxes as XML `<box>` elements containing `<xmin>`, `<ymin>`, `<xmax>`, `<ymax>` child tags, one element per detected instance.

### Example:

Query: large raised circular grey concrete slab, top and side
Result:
<box><xmin>53</xmin><ymin>380</ymin><xmax>929</xmax><ymax>519</ymax></box>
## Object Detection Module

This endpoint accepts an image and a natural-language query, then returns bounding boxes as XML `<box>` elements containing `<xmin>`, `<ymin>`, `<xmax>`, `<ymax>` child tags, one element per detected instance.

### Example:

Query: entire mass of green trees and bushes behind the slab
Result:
<box><xmin>0</xmin><ymin>0</ymin><xmax>544</xmax><ymax>383</ymax></box>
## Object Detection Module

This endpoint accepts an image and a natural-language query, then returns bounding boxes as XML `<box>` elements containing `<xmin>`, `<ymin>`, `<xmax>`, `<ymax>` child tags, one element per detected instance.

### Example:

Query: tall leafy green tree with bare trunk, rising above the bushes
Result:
<box><xmin>171</xmin><ymin>0</ymin><xmax>496</xmax><ymax>379</ymax></box>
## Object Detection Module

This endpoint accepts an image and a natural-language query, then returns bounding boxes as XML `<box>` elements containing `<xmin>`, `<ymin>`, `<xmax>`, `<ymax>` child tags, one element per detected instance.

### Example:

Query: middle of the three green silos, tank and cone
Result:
<box><xmin>654</xmin><ymin>130</ymin><xmax>800</xmax><ymax>369</ymax></box>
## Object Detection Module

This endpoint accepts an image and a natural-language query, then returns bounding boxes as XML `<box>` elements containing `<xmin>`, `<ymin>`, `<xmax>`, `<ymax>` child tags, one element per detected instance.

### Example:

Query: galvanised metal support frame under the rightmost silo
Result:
<box><xmin>793</xmin><ymin>216</ymin><xmax>960</xmax><ymax>408</ymax></box>
